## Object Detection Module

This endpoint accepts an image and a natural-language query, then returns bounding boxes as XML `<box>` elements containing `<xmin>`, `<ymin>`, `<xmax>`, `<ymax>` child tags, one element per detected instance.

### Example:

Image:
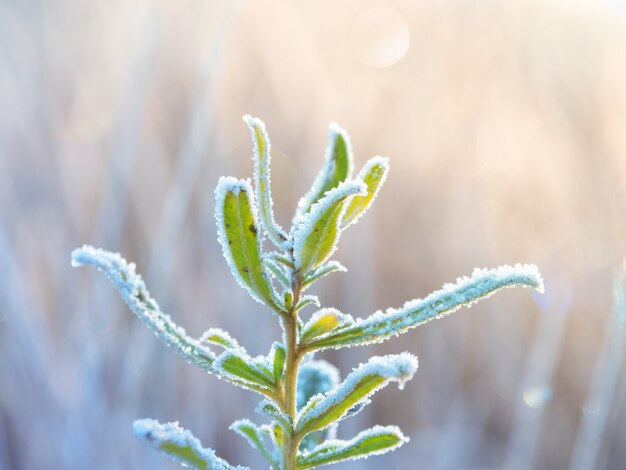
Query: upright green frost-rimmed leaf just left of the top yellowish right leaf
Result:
<box><xmin>296</xmin><ymin>123</ymin><xmax>354</xmax><ymax>219</ymax></box>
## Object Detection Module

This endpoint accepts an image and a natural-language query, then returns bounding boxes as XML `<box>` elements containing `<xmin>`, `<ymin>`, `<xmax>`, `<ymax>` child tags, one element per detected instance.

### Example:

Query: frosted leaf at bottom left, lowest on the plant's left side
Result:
<box><xmin>133</xmin><ymin>419</ymin><xmax>247</xmax><ymax>470</ymax></box>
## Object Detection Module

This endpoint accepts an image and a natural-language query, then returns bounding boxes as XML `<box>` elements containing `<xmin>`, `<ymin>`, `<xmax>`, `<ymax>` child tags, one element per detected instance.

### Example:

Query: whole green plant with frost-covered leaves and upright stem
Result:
<box><xmin>72</xmin><ymin>116</ymin><xmax>543</xmax><ymax>470</ymax></box>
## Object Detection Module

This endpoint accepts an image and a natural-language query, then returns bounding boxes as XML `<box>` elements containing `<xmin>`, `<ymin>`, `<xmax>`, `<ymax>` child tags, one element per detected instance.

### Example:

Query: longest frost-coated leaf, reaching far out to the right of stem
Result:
<box><xmin>306</xmin><ymin>264</ymin><xmax>543</xmax><ymax>351</ymax></box>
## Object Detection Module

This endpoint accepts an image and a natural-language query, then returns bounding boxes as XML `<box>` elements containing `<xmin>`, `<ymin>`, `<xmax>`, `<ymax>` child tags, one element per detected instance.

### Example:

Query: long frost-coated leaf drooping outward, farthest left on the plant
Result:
<box><xmin>72</xmin><ymin>245</ymin><xmax>215</xmax><ymax>372</ymax></box>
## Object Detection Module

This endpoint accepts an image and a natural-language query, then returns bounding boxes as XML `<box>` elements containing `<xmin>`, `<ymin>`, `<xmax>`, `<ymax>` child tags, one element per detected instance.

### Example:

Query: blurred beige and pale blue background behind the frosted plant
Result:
<box><xmin>0</xmin><ymin>0</ymin><xmax>626</xmax><ymax>469</ymax></box>
